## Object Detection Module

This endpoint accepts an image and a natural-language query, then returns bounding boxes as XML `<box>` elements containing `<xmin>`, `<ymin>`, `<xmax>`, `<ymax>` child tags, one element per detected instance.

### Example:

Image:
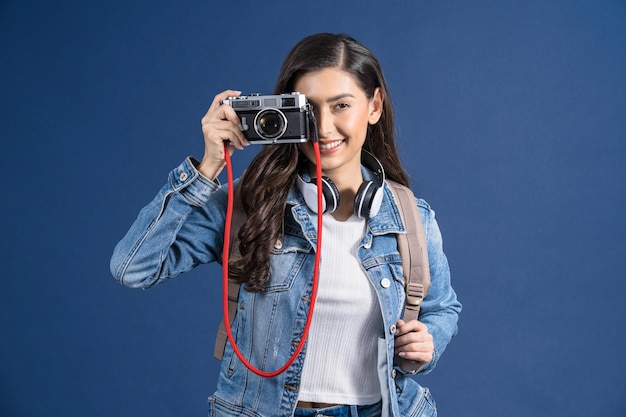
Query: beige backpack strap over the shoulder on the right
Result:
<box><xmin>387</xmin><ymin>180</ymin><xmax>430</xmax><ymax>322</ymax></box>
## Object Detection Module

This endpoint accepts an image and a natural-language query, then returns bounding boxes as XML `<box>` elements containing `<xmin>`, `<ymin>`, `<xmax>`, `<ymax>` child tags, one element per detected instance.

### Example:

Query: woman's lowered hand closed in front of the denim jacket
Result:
<box><xmin>395</xmin><ymin>320</ymin><xmax>435</xmax><ymax>372</ymax></box>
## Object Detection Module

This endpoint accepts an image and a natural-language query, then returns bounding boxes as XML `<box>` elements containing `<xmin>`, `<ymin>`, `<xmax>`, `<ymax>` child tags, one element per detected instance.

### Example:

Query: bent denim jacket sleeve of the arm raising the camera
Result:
<box><xmin>110</xmin><ymin>158</ymin><xmax>227</xmax><ymax>288</ymax></box>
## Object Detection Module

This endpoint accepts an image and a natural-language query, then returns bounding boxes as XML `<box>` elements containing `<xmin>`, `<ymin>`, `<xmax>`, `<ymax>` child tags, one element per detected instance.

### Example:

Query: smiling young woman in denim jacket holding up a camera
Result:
<box><xmin>111</xmin><ymin>33</ymin><xmax>461</xmax><ymax>417</ymax></box>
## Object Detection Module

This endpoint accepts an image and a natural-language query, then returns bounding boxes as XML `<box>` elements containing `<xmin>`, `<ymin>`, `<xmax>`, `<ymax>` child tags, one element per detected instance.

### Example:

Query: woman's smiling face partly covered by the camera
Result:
<box><xmin>294</xmin><ymin>68</ymin><xmax>383</xmax><ymax>184</ymax></box>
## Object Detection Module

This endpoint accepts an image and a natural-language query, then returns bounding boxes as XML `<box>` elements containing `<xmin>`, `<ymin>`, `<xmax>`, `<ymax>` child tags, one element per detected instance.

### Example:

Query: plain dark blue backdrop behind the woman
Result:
<box><xmin>0</xmin><ymin>0</ymin><xmax>626</xmax><ymax>417</ymax></box>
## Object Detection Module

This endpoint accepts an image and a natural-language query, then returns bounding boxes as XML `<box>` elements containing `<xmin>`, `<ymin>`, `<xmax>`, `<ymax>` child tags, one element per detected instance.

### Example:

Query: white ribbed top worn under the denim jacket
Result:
<box><xmin>298</xmin><ymin>214</ymin><xmax>383</xmax><ymax>405</ymax></box>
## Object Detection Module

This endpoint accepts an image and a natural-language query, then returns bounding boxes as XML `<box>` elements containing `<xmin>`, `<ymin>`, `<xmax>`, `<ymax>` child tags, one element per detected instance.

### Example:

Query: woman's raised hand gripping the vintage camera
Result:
<box><xmin>198</xmin><ymin>90</ymin><xmax>250</xmax><ymax>180</ymax></box>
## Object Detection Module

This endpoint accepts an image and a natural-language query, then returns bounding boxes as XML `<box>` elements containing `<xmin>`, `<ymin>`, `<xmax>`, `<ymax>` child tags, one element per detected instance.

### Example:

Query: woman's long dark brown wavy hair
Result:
<box><xmin>229</xmin><ymin>33</ymin><xmax>408</xmax><ymax>292</ymax></box>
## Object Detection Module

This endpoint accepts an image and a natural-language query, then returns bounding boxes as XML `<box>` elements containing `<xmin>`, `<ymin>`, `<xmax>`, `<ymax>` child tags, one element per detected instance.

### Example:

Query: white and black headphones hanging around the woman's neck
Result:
<box><xmin>296</xmin><ymin>150</ymin><xmax>385</xmax><ymax>218</ymax></box>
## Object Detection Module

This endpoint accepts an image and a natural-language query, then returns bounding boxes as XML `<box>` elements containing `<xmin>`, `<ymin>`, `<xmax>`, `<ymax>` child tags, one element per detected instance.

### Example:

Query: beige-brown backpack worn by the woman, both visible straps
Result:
<box><xmin>213</xmin><ymin>180</ymin><xmax>430</xmax><ymax>360</ymax></box>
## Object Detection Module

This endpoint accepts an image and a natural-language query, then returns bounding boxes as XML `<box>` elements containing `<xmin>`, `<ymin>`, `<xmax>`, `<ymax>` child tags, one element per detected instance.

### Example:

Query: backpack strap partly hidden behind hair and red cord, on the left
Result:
<box><xmin>213</xmin><ymin>188</ymin><xmax>246</xmax><ymax>361</ymax></box>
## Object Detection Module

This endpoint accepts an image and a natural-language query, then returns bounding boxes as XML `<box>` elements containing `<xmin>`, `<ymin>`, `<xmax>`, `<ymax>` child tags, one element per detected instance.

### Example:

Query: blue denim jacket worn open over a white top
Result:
<box><xmin>111</xmin><ymin>158</ymin><xmax>461</xmax><ymax>417</ymax></box>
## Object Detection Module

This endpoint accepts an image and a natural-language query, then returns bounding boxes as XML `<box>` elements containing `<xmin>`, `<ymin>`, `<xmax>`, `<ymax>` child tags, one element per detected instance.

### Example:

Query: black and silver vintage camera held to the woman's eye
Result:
<box><xmin>222</xmin><ymin>93</ymin><xmax>311</xmax><ymax>144</ymax></box>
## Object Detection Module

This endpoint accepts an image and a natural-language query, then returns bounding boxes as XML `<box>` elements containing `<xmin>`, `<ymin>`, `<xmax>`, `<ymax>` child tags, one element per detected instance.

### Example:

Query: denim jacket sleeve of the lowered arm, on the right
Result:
<box><xmin>418</xmin><ymin>200</ymin><xmax>462</xmax><ymax>374</ymax></box>
